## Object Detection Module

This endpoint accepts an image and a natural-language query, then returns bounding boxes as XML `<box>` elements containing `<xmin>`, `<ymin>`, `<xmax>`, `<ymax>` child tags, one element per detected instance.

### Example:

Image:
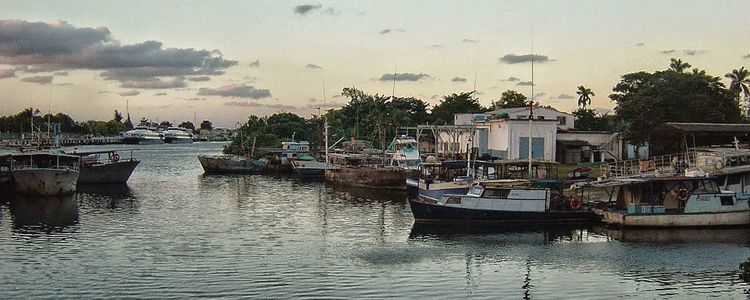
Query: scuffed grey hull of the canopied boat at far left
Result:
<box><xmin>12</xmin><ymin>169</ymin><xmax>79</xmax><ymax>196</ymax></box>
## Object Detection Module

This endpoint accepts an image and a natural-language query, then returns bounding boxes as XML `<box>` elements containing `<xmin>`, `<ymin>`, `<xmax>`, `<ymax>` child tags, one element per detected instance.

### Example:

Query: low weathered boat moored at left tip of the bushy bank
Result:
<box><xmin>198</xmin><ymin>154</ymin><xmax>272</xmax><ymax>174</ymax></box>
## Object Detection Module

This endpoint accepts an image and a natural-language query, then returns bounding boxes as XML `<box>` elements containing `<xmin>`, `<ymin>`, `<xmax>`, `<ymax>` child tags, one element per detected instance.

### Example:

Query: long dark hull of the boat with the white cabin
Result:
<box><xmin>409</xmin><ymin>197</ymin><xmax>596</xmax><ymax>223</ymax></box>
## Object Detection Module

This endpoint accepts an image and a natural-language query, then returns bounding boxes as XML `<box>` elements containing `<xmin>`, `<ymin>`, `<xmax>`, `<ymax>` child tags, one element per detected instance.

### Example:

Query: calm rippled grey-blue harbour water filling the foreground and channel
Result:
<box><xmin>0</xmin><ymin>144</ymin><xmax>750</xmax><ymax>299</ymax></box>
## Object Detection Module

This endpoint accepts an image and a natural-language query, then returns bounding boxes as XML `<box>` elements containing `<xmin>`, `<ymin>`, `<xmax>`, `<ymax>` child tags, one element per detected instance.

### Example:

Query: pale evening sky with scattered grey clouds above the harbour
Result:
<box><xmin>0</xmin><ymin>0</ymin><xmax>750</xmax><ymax>127</ymax></box>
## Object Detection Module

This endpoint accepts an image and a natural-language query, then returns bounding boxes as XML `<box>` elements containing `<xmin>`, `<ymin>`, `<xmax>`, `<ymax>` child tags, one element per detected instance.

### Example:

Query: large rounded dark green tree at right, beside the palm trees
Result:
<box><xmin>609</xmin><ymin>60</ymin><xmax>742</xmax><ymax>143</ymax></box>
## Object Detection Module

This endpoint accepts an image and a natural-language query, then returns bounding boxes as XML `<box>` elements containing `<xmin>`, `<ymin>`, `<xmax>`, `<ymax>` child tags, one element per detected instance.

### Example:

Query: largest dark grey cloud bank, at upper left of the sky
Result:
<box><xmin>0</xmin><ymin>20</ymin><xmax>237</xmax><ymax>82</ymax></box>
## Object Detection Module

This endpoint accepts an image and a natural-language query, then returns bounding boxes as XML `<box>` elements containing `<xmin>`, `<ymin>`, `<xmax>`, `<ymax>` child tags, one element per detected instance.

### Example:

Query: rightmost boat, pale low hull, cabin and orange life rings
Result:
<box><xmin>580</xmin><ymin>174</ymin><xmax>750</xmax><ymax>228</ymax></box>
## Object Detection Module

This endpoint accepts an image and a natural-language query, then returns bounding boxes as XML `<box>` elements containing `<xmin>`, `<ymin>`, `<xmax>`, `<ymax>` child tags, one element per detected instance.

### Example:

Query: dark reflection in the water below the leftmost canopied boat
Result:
<box><xmin>9</xmin><ymin>195</ymin><xmax>78</xmax><ymax>232</ymax></box>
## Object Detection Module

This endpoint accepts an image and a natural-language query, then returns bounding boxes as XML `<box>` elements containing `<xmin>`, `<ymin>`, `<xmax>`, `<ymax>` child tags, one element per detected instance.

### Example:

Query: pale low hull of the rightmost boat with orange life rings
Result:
<box><xmin>598</xmin><ymin>211</ymin><xmax>750</xmax><ymax>228</ymax></box>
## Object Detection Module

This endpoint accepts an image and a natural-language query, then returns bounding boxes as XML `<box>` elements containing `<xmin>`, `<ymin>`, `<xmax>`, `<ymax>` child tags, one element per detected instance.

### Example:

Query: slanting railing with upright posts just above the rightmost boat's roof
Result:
<box><xmin>602</xmin><ymin>152</ymin><xmax>696</xmax><ymax>178</ymax></box>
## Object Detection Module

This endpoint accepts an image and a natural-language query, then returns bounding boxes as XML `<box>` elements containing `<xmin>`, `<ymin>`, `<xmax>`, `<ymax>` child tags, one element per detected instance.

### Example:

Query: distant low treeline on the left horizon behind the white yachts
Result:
<box><xmin>0</xmin><ymin>108</ymin><xmax>212</xmax><ymax>135</ymax></box>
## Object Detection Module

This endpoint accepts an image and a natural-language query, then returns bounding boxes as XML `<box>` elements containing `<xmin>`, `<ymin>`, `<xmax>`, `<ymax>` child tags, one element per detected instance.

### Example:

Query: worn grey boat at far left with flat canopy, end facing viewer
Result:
<box><xmin>10</xmin><ymin>151</ymin><xmax>80</xmax><ymax>196</ymax></box>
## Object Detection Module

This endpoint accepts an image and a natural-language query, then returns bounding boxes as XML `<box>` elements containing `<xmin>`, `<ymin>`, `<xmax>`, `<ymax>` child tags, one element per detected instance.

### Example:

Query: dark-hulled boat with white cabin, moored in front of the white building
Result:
<box><xmin>409</xmin><ymin>179</ymin><xmax>596</xmax><ymax>224</ymax></box>
